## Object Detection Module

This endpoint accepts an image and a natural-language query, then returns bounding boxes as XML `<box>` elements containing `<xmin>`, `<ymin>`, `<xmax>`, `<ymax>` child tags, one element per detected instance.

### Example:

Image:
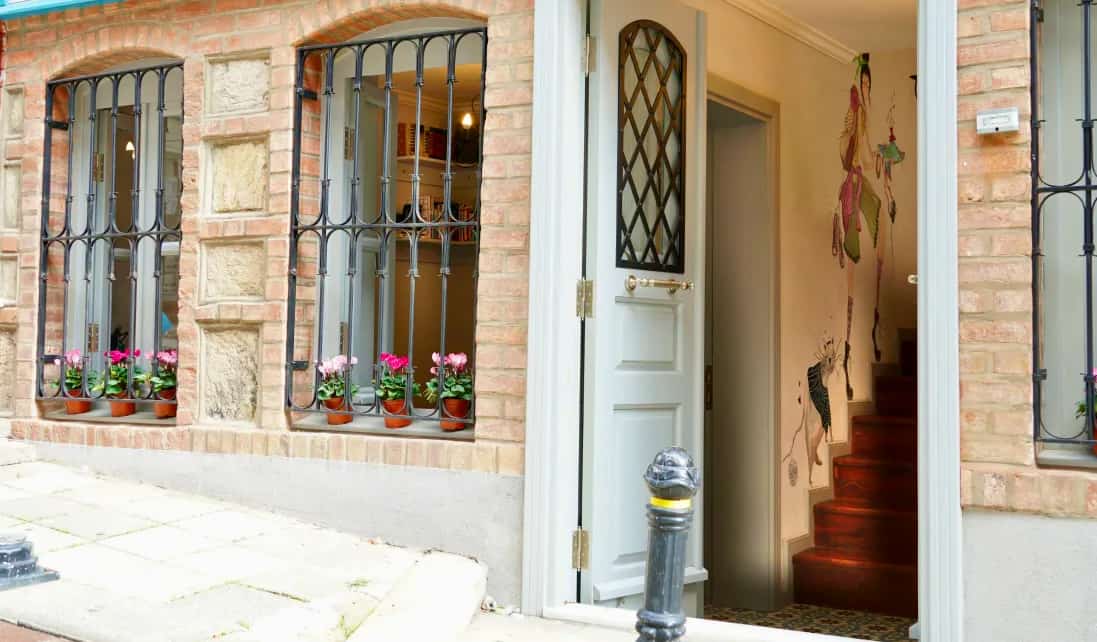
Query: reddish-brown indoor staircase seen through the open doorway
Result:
<box><xmin>792</xmin><ymin>359</ymin><xmax>918</xmax><ymax>618</ymax></box>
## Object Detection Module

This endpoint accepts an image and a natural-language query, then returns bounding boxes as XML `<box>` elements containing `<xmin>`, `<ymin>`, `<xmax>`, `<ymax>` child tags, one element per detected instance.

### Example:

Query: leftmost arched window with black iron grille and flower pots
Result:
<box><xmin>37</xmin><ymin>60</ymin><xmax>183</xmax><ymax>409</ymax></box>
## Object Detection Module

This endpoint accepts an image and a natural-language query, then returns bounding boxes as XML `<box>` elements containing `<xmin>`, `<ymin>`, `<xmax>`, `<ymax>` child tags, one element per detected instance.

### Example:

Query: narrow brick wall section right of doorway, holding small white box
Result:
<box><xmin>958</xmin><ymin>0</ymin><xmax>1097</xmax><ymax>517</ymax></box>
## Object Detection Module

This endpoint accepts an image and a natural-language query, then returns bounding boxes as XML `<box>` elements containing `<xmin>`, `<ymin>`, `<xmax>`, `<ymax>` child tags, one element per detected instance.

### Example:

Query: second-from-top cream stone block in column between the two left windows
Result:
<box><xmin>211</xmin><ymin>139</ymin><xmax>270</xmax><ymax>214</ymax></box>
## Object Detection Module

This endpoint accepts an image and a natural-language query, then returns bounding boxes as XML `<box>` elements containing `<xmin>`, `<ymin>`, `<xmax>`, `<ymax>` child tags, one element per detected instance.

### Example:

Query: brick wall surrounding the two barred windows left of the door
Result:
<box><xmin>0</xmin><ymin>0</ymin><xmax>533</xmax><ymax>474</ymax></box>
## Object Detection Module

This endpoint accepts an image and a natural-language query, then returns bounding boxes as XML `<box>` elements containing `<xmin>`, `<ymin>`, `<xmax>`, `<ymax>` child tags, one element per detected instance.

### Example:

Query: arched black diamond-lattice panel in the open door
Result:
<box><xmin>617</xmin><ymin>20</ymin><xmax>686</xmax><ymax>273</ymax></box>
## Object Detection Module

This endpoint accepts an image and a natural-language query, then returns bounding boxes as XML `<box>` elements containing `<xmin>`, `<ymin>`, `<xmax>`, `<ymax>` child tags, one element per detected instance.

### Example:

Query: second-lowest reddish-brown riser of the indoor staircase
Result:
<box><xmin>815</xmin><ymin>504</ymin><xmax>918</xmax><ymax>564</ymax></box>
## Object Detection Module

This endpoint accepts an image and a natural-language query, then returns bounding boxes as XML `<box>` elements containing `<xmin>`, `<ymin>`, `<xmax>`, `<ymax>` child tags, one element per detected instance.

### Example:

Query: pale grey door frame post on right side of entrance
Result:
<box><xmin>918</xmin><ymin>0</ymin><xmax>963</xmax><ymax>642</ymax></box>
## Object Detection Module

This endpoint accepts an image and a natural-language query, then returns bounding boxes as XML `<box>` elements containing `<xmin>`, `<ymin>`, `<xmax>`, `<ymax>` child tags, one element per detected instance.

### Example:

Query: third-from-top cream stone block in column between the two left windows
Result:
<box><xmin>201</xmin><ymin>241</ymin><xmax>267</xmax><ymax>301</ymax></box>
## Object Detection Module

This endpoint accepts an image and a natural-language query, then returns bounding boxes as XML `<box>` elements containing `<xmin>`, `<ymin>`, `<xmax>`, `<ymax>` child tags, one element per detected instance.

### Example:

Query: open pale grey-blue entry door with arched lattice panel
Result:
<box><xmin>580</xmin><ymin>0</ymin><xmax>705</xmax><ymax>608</ymax></box>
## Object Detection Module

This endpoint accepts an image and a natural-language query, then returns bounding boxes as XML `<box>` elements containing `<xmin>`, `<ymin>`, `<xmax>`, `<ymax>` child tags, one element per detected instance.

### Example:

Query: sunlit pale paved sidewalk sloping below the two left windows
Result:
<box><xmin>0</xmin><ymin>449</ymin><xmax>485</xmax><ymax>642</ymax></box>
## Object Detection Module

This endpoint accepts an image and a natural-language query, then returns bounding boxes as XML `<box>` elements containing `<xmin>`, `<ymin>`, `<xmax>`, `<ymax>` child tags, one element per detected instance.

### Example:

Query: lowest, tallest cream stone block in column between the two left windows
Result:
<box><xmin>199</xmin><ymin>326</ymin><xmax>259</xmax><ymax>424</ymax></box>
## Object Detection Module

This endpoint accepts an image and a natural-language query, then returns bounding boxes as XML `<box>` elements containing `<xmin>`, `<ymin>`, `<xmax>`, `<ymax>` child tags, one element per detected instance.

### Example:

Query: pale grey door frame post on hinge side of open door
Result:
<box><xmin>522</xmin><ymin>0</ymin><xmax>586</xmax><ymax>615</ymax></box>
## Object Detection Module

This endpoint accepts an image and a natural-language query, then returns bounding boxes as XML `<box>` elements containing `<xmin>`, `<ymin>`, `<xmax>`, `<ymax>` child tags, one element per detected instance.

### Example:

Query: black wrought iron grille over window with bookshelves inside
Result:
<box><xmin>285</xmin><ymin>27</ymin><xmax>487</xmax><ymax>430</ymax></box>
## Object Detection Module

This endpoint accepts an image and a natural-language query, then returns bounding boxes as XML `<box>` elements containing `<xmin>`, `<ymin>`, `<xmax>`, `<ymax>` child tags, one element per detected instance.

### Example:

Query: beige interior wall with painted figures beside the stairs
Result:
<box><xmin>688</xmin><ymin>0</ymin><xmax>917</xmax><ymax>592</ymax></box>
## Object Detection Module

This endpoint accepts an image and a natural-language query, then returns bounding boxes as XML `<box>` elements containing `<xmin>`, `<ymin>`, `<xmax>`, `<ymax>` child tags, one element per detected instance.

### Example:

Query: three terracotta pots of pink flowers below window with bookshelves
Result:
<box><xmin>316</xmin><ymin>352</ymin><xmax>473</xmax><ymax>432</ymax></box>
